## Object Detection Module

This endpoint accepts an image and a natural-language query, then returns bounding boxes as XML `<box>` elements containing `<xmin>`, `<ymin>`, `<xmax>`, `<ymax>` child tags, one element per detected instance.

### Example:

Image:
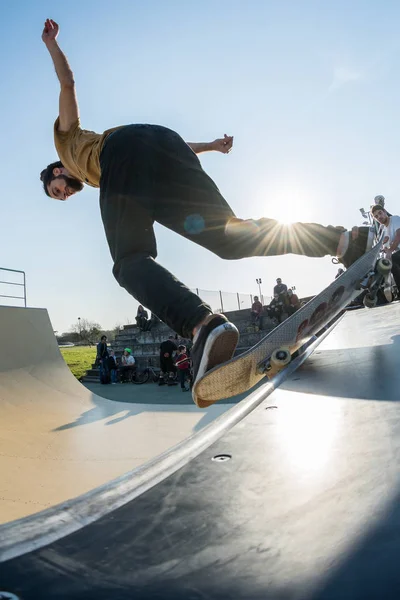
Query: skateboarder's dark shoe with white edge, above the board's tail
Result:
<box><xmin>191</xmin><ymin>314</ymin><xmax>239</xmax><ymax>385</ymax></box>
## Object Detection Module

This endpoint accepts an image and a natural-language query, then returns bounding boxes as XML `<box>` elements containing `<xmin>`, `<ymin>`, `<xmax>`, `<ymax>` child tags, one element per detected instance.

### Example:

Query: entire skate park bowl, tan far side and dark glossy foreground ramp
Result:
<box><xmin>0</xmin><ymin>303</ymin><xmax>400</xmax><ymax>600</ymax></box>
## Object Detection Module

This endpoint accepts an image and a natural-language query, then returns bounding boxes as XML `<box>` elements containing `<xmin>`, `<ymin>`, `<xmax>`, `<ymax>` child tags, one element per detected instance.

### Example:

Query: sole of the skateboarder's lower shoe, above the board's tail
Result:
<box><xmin>193</xmin><ymin>322</ymin><xmax>239</xmax><ymax>385</ymax></box>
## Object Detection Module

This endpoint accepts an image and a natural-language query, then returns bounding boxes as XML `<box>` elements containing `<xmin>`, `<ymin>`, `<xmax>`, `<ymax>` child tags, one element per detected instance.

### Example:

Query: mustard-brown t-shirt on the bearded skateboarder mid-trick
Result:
<box><xmin>54</xmin><ymin>118</ymin><xmax>121</xmax><ymax>187</ymax></box>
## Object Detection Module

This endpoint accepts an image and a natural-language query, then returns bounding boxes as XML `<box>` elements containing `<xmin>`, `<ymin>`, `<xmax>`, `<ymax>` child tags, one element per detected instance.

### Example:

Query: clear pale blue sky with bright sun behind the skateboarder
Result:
<box><xmin>0</xmin><ymin>0</ymin><xmax>400</xmax><ymax>331</ymax></box>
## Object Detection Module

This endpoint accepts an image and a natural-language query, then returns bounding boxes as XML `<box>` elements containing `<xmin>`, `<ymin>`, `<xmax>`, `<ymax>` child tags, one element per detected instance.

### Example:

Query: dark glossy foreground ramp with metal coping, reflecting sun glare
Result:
<box><xmin>0</xmin><ymin>303</ymin><xmax>400</xmax><ymax>600</ymax></box>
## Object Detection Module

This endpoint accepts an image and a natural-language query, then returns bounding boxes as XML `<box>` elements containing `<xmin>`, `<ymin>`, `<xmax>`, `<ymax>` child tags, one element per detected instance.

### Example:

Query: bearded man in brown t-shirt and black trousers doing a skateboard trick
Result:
<box><xmin>40</xmin><ymin>19</ymin><xmax>373</xmax><ymax>394</ymax></box>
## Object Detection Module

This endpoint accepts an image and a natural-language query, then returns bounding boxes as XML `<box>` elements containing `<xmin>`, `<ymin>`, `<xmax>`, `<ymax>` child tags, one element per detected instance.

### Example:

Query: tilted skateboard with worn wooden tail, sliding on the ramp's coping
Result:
<box><xmin>192</xmin><ymin>238</ymin><xmax>390</xmax><ymax>408</ymax></box>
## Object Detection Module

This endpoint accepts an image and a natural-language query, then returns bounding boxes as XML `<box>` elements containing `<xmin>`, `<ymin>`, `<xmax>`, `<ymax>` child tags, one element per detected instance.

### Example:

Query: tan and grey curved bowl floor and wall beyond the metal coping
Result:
<box><xmin>0</xmin><ymin>307</ymin><xmax>234</xmax><ymax>523</ymax></box>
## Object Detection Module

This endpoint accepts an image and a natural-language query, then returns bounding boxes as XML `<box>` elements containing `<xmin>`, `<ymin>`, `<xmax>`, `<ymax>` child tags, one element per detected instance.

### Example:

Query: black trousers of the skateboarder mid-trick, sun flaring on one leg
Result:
<box><xmin>100</xmin><ymin>125</ymin><xmax>340</xmax><ymax>338</ymax></box>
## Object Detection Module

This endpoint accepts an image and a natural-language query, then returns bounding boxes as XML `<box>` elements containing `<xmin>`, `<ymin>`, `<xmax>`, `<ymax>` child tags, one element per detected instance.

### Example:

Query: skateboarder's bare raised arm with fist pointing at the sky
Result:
<box><xmin>42</xmin><ymin>19</ymin><xmax>79</xmax><ymax>131</ymax></box>
